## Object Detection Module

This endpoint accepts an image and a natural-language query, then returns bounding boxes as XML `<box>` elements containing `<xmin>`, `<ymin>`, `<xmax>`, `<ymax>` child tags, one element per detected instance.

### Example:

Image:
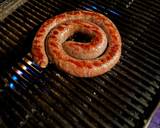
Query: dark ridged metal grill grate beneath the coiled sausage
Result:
<box><xmin>0</xmin><ymin>0</ymin><xmax>160</xmax><ymax>128</ymax></box>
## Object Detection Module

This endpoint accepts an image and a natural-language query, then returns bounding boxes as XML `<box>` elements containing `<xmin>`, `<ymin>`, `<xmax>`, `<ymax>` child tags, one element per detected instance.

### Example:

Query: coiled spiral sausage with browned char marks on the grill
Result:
<box><xmin>32</xmin><ymin>10</ymin><xmax>122</xmax><ymax>77</ymax></box>
